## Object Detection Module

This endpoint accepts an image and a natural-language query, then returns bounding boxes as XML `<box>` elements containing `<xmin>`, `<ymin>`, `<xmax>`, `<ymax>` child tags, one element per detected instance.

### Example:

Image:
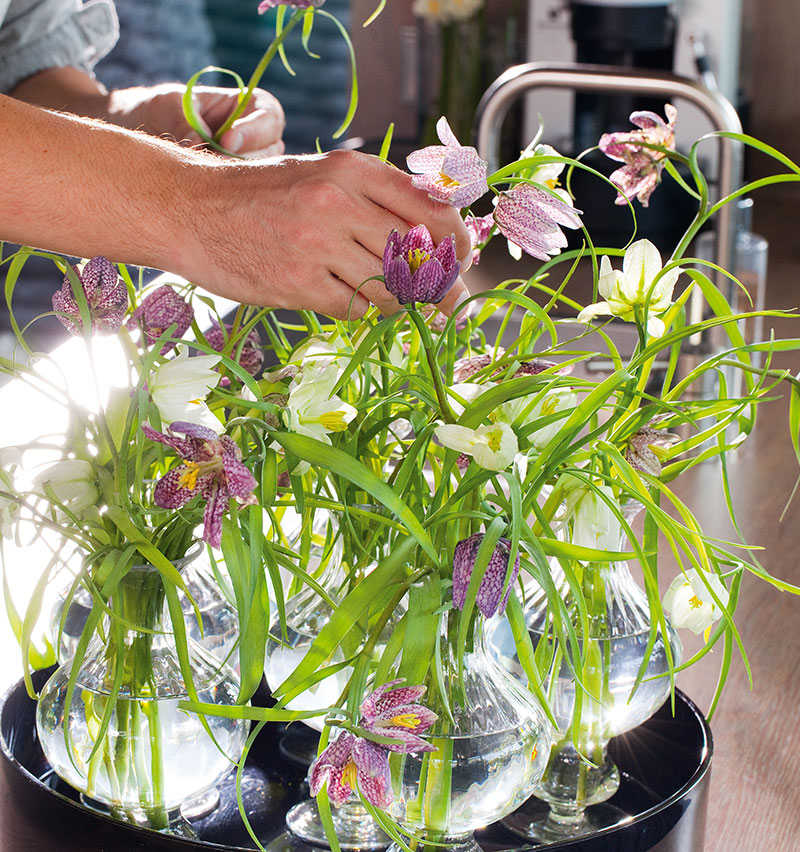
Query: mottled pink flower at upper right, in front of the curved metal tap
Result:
<box><xmin>598</xmin><ymin>104</ymin><xmax>678</xmax><ymax>207</ymax></box>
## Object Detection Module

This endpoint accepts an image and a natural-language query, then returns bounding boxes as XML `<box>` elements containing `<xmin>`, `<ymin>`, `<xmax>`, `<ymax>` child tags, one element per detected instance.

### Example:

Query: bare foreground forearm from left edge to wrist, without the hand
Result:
<box><xmin>0</xmin><ymin>97</ymin><xmax>213</xmax><ymax>272</ymax></box>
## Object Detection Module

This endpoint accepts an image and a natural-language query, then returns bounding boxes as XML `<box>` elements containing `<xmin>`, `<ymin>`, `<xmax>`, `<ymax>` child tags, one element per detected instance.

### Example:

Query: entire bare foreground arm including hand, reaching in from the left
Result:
<box><xmin>0</xmin><ymin>97</ymin><xmax>470</xmax><ymax>317</ymax></box>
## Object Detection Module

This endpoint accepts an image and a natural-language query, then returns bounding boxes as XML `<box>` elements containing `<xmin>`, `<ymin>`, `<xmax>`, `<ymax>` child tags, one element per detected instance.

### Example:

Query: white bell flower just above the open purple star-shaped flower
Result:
<box><xmin>148</xmin><ymin>349</ymin><xmax>224</xmax><ymax>434</ymax></box>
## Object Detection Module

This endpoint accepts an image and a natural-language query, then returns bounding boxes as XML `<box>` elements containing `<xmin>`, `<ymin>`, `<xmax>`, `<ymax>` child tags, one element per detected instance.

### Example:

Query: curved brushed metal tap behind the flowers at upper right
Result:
<box><xmin>475</xmin><ymin>62</ymin><xmax>743</xmax><ymax>269</ymax></box>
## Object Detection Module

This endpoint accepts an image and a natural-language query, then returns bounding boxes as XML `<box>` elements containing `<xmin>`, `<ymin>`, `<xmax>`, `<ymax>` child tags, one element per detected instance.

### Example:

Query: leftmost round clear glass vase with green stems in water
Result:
<box><xmin>36</xmin><ymin>565</ymin><xmax>249</xmax><ymax>834</ymax></box>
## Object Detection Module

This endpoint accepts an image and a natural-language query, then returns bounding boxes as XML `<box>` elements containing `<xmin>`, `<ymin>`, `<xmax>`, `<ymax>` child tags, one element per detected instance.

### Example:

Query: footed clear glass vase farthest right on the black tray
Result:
<box><xmin>500</xmin><ymin>502</ymin><xmax>681</xmax><ymax>844</ymax></box>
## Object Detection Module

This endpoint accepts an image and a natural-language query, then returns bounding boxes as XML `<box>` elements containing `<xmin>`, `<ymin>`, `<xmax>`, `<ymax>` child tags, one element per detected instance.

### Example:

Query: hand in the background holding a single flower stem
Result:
<box><xmin>108</xmin><ymin>83</ymin><xmax>286</xmax><ymax>157</ymax></box>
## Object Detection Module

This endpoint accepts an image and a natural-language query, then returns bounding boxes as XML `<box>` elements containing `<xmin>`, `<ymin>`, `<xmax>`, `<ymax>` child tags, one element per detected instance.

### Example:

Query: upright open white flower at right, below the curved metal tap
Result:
<box><xmin>578</xmin><ymin>240</ymin><xmax>681</xmax><ymax>337</ymax></box>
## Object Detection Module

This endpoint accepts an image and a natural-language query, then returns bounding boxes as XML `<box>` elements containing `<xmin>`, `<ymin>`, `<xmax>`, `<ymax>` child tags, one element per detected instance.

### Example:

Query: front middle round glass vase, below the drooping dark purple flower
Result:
<box><xmin>390</xmin><ymin>610</ymin><xmax>551</xmax><ymax>852</ymax></box>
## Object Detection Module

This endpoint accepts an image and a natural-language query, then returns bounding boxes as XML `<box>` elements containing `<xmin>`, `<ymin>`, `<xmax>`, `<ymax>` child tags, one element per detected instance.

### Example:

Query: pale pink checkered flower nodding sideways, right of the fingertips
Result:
<box><xmin>494</xmin><ymin>183</ymin><xmax>581</xmax><ymax>260</ymax></box>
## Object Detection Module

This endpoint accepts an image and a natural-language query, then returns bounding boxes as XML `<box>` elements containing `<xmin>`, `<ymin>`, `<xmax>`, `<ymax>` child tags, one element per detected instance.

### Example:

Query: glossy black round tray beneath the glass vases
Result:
<box><xmin>0</xmin><ymin>671</ymin><xmax>712</xmax><ymax>852</ymax></box>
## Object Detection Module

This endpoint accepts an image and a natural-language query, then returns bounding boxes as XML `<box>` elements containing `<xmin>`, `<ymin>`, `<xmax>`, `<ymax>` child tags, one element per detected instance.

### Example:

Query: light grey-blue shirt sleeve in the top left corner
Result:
<box><xmin>0</xmin><ymin>0</ymin><xmax>119</xmax><ymax>92</ymax></box>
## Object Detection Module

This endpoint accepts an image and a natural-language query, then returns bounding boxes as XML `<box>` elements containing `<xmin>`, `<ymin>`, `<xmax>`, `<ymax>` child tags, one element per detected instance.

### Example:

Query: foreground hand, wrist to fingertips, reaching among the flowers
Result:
<box><xmin>178</xmin><ymin>146</ymin><xmax>471</xmax><ymax>319</ymax></box>
